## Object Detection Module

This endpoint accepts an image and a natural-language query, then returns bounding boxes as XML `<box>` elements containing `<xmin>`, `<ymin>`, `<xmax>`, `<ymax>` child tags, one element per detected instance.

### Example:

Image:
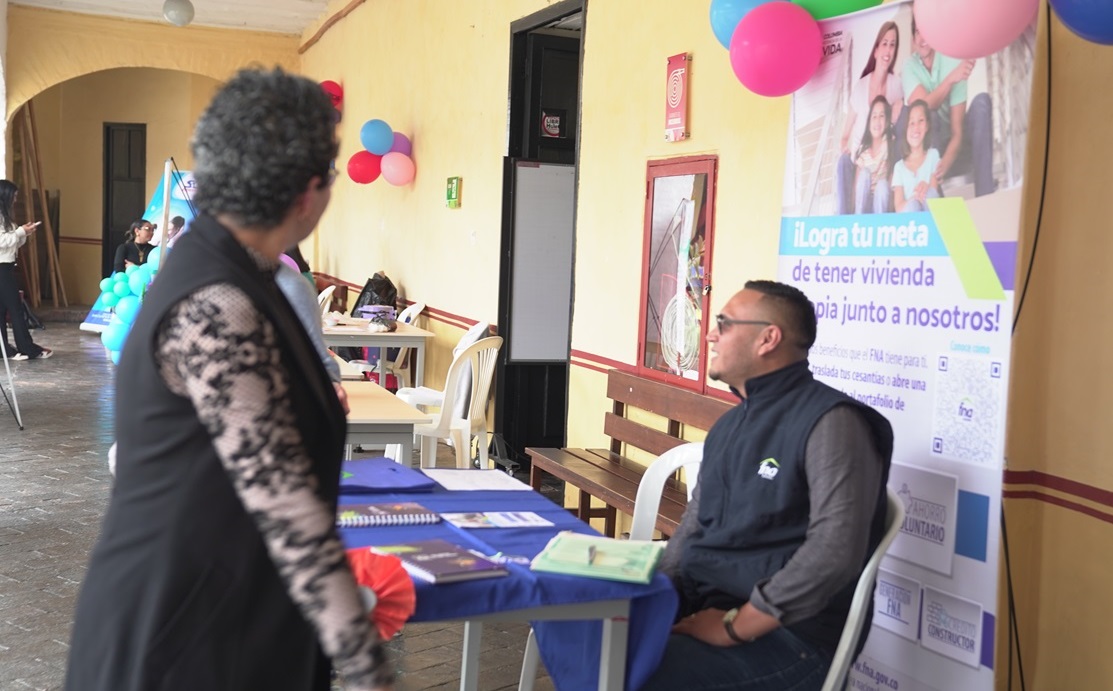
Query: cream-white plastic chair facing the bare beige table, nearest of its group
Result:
<box><xmin>387</xmin><ymin>336</ymin><xmax>502</xmax><ymax>468</ymax></box>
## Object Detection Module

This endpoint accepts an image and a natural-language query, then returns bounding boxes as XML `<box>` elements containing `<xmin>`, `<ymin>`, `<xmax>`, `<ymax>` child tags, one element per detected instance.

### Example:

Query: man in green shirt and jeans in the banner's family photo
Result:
<box><xmin>897</xmin><ymin>19</ymin><xmax>996</xmax><ymax>197</ymax></box>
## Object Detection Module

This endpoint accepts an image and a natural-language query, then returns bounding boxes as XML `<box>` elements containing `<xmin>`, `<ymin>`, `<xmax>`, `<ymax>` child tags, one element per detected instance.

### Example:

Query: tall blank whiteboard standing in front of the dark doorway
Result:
<box><xmin>509</xmin><ymin>161</ymin><xmax>575</xmax><ymax>362</ymax></box>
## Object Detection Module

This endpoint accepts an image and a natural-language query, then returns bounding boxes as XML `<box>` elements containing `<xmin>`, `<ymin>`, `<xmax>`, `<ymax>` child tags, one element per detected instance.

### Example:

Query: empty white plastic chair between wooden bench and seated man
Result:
<box><xmin>518</xmin><ymin>442</ymin><xmax>703</xmax><ymax>691</ymax></box>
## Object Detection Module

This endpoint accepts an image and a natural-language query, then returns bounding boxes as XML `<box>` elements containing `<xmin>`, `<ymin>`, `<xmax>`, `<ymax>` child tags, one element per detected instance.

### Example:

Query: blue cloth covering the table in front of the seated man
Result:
<box><xmin>341</xmin><ymin>486</ymin><xmax>677</xmax><ymax>689</ymax></box>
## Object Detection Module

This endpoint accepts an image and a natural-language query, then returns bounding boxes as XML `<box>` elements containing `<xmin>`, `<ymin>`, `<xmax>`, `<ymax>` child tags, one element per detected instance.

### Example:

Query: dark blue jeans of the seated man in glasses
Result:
<box><xmin>641</xmin><ymin>629</ymin><xmax>830</xmax><ymax>691</ymax></box>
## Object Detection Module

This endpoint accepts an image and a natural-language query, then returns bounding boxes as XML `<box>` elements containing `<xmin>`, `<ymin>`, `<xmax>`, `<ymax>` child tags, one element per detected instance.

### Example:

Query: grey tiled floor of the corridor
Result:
<box><xmin>0</xmin><ymin>322</ymin><xmax>553</xmax><ymax>691</ymax></box>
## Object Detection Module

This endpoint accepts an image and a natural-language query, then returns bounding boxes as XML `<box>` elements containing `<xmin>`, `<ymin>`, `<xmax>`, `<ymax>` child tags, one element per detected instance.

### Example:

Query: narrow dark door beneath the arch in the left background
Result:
<box><xmin>100</xmin><ymin>122</ymin><xmax>146</xmax><ymax>276</ymax></box>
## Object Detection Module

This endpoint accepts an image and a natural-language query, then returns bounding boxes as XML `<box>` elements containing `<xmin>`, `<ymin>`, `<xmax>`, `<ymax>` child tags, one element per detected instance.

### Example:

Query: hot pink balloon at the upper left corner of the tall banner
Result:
<box><xmin>730</xmin><ymin>2</ymin><xmax>824</xmax><ymax>96</ymax></box>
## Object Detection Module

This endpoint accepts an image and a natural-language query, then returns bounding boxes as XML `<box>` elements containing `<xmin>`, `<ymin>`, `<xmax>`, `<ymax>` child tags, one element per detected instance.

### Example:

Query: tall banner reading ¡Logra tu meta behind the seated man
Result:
<box><xmin>779</xmin><ymin>2</ymin><xmax>1035</xmax><ymax>691</ymax></box>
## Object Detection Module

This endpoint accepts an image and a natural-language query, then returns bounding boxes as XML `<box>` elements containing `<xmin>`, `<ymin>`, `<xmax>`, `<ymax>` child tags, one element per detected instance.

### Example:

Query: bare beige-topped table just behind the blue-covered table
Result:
<box><xmin>343</xmin><ymin>382</ymin><xmax>430</xmax><ymax>465</ymax></box>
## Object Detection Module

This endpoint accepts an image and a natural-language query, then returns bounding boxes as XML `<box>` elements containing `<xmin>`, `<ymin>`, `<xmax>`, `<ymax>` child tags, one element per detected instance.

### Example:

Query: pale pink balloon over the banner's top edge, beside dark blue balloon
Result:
<box><xmin>913</xmin><ymin>0</ymin><xmax>1040</xmax><ymax>60</ymax></box>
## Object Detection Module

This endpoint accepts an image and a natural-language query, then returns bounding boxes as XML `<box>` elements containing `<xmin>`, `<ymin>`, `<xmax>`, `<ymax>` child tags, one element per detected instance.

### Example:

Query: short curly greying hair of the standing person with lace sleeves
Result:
<box><xmin>190</xmin><ymin>68</ymin><xmax>337</xmax><ymax>228</ymax></box>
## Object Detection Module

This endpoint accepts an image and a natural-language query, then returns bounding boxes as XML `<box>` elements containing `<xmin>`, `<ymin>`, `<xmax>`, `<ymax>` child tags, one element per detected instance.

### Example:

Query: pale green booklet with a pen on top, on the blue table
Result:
<box><xmin>530</xmin><ymin>531</ymin><xmax>664</xmax><ymax>583</ymax></box>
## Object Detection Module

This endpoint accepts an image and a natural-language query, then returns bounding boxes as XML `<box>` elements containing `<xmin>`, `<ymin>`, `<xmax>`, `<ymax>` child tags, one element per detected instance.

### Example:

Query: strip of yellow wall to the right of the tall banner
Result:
<box><xmin>998</xmin><ymin>8</ymin><xmax>1113</xmax><ymax>689</ymax></box>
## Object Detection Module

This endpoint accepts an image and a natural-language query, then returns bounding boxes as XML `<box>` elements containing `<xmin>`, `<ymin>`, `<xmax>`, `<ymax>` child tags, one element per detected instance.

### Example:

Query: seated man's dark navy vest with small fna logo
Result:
<box><xmin>680</xmin><ymin>361</ymin><xmax>893</xmax><ymax>651</ymax></box>
